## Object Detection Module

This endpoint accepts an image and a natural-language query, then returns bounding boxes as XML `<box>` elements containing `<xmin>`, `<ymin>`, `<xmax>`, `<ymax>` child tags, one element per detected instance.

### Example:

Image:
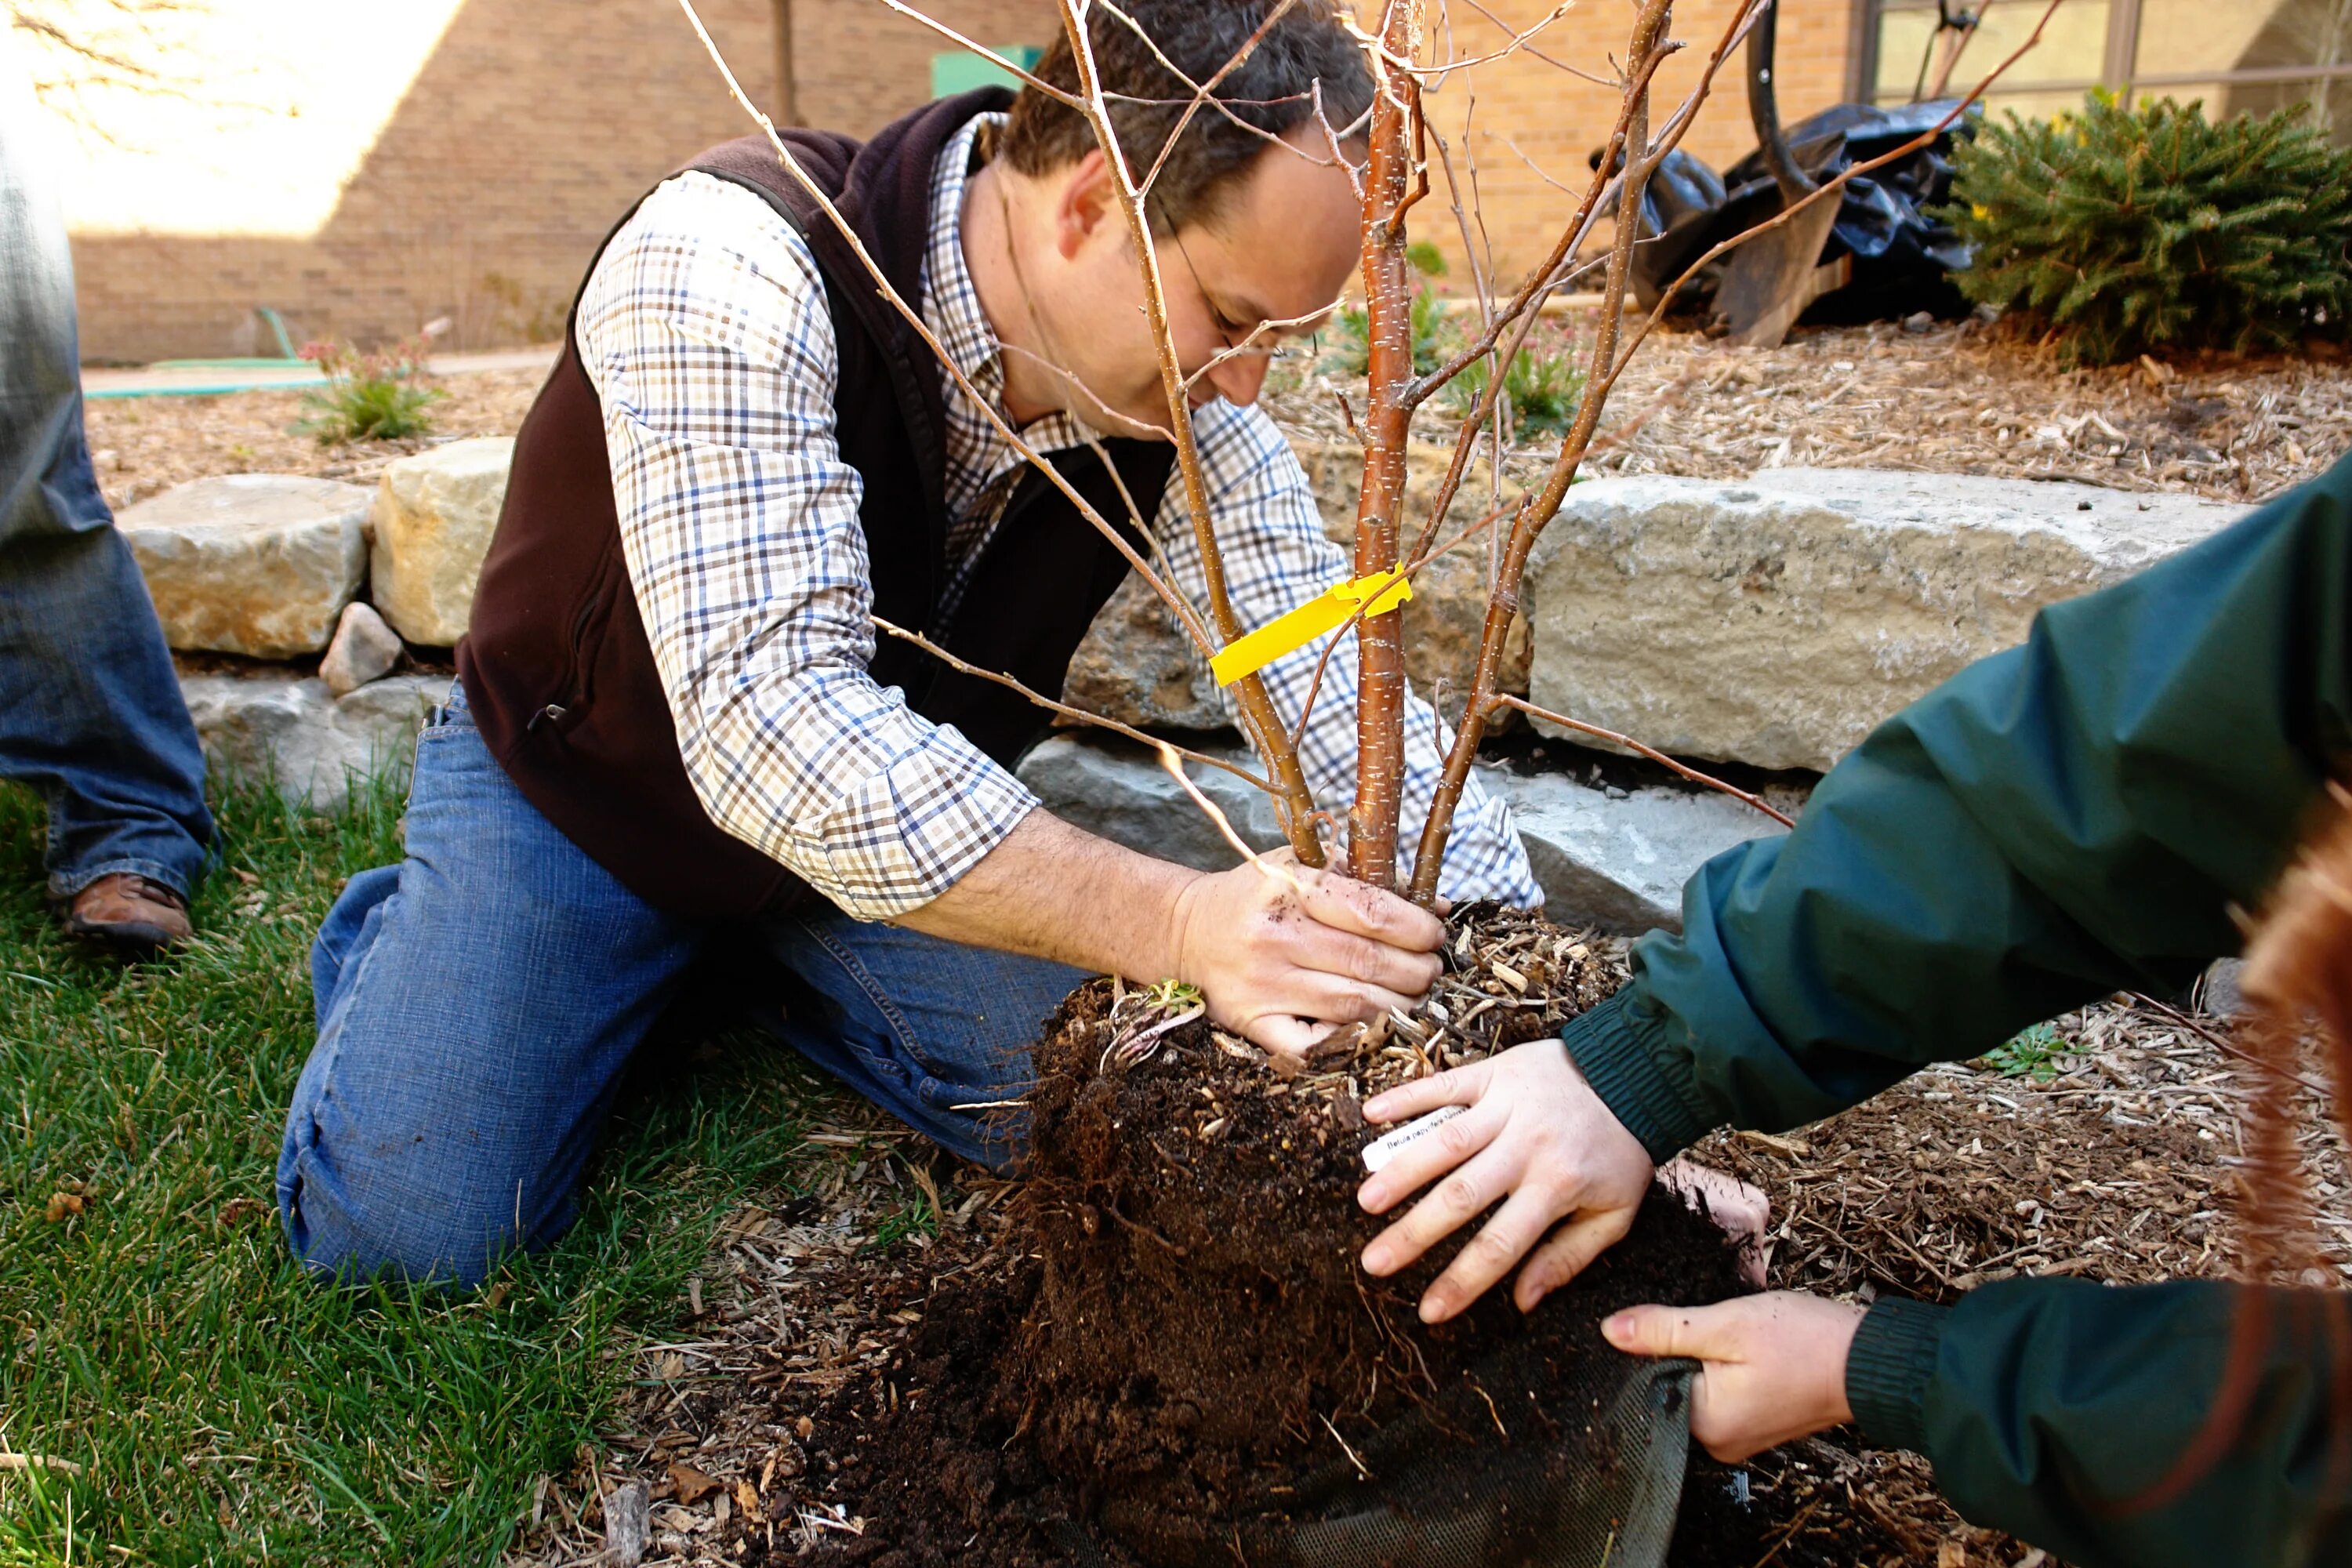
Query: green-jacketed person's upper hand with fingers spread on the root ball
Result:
<box><xmin>1355</xmin><ymin>1039</ymin><xmax>1651</xmax><ymax>1323</ymax></box>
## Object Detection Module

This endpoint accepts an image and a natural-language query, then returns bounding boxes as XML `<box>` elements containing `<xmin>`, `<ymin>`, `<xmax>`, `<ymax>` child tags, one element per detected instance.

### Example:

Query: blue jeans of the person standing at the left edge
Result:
<box><xmin>0</xmin><ymin>82</ymin><xmax>212</xmax><ymax>898</ymax></box>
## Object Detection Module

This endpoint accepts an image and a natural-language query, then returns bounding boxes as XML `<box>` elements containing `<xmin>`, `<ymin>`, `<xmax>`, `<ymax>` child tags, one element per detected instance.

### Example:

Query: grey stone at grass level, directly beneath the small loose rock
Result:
<box><xmin>179</xmin><ymin>675</ymin><xmax>449</xmax><ymax>811</ymax></box>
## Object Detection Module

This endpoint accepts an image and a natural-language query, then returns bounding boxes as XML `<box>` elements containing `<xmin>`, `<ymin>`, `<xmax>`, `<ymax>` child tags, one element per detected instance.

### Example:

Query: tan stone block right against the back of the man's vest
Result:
<box><xmin>369</xmin><ymin>435</ymin><xmax>515</xmax><ymax>649</ymax></box>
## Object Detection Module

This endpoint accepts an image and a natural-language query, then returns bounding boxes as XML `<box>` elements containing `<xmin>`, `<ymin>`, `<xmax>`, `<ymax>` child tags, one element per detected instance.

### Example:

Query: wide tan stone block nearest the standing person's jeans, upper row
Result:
<box><xmin>115</xmin><ymin>475</ymin><xmax>367</xmax><ymax>659</ymax></box>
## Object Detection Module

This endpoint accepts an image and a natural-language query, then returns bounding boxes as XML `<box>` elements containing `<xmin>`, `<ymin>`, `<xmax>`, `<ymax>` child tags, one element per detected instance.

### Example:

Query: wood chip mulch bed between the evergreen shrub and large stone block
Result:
<box><xmin>1265</xmin><ymin>313</ymin><xmax>2352</xmax><ymax>512</ymax></box>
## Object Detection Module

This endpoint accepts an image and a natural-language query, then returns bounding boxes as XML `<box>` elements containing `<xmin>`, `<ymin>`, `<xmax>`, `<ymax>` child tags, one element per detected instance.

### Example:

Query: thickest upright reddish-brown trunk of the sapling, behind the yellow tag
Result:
<box><xmin>1348</xmin><ymin>0</ymin><xmax>1428</xmax><ymax>888</ymax></box>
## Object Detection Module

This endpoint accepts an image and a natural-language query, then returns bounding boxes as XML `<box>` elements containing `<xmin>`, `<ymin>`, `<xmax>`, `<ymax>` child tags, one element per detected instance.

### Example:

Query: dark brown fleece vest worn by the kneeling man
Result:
<box><xmin>456</xmin><ymin>89</ymin><xmax>1174</xmax><ymax>916</ymax></box>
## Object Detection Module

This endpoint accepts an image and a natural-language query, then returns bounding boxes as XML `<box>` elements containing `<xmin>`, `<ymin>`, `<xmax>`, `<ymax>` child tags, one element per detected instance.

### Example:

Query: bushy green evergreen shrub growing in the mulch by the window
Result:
<box><xmin>1943</xmin><ymin>92</ymin><xmax>2352</xmax><ymax>365</ymax></box>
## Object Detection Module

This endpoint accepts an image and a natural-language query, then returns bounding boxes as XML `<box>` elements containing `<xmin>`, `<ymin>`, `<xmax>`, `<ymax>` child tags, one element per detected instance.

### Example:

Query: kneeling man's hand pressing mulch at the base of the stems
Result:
<box><xmin>1176</xmin><ymin>848</ymin><xmax>1446</xmax><ymax>1055</ymax></box>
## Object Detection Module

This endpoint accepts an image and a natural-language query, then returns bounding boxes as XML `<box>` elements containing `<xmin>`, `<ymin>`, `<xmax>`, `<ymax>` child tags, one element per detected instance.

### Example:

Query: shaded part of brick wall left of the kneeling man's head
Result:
<box><xmin>73</xmin><ymin>0</ymin><xmax>1056</xmax><ymax>360</ymax></box>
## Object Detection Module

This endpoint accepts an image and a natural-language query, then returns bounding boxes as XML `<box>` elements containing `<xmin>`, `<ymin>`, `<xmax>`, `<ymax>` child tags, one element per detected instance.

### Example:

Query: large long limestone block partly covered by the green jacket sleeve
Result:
<box><xmin>1526</xmin><ymin>468</ymin><xmax>2246</xmax><ymax>769</ymax></box>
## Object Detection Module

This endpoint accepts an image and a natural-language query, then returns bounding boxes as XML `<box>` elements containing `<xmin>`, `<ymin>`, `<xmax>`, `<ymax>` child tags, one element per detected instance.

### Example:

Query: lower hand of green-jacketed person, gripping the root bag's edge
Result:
<box><xmin>1602</xmin><ymin>1290</ymin><xmax>1863</xmax><ymax>1465</ymax></box>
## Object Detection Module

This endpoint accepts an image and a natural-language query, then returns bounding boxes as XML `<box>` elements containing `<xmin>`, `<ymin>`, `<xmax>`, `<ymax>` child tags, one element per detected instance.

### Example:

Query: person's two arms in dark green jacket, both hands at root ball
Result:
<box><xmin>1359</xmin><ymin>446</ymin><xmax>2352</xmax><ymax>1568</ymax></box>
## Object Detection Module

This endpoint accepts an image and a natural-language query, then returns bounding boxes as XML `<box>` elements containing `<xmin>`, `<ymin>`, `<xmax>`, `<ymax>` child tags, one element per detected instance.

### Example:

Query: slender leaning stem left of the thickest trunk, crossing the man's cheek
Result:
<box><xmin>1049</xmin><ymin>0</ymin><xmax>1324</xmax><ymax>865</ymax></box>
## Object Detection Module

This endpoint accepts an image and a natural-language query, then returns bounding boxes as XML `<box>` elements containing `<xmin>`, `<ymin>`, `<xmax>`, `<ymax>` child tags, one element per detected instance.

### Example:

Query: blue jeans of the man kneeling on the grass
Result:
<box><xmin>278</xmin><ymin>689</ymin><xmax>1084</xmax><ymax>1286</ymax></box>
